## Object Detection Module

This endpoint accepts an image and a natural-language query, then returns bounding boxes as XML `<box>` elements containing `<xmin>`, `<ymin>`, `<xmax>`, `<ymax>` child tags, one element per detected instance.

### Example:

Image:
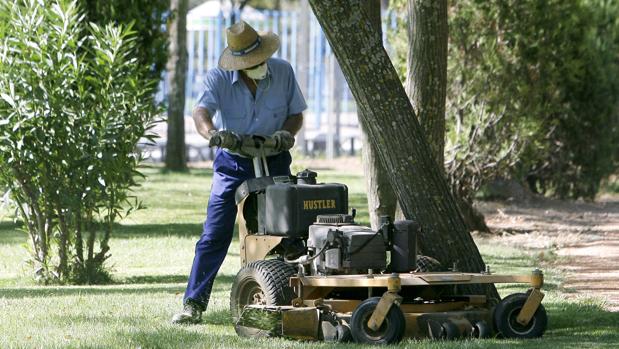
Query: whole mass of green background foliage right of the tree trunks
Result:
<box><xmin>392</xmin><ymin>0</ymin><xmax>619</xmax><ymax>199</ymax></box>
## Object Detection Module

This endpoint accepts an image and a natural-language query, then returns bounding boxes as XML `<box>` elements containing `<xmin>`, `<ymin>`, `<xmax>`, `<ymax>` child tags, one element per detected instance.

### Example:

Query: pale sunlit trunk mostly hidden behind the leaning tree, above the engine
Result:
<box><xmin>359</xmin><ymin>0</ymin><xmax>398</xmax><ymax>229</ymax></box>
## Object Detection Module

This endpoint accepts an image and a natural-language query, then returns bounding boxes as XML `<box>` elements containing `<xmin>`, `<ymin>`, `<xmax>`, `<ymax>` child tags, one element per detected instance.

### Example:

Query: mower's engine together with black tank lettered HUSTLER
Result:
<box><xmin>236</xmin><ymin>170</ymin><xmax>418</xmax><ymax>276</ymax></box>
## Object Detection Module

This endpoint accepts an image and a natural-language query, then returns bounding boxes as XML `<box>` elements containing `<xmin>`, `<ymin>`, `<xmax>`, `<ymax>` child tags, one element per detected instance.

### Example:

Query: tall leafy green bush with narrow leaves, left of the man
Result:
<box><xmin>0</xmin><ymin>0</ymin><xmax>155</xmax><ymax>283</ymax></box>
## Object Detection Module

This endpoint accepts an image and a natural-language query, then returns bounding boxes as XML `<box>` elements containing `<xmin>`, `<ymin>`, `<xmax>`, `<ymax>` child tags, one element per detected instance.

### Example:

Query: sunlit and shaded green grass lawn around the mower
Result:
<box><xmin>0</xmin><ymin>168</ymin><xmax>619</xmax><ymax>348</ymax></box>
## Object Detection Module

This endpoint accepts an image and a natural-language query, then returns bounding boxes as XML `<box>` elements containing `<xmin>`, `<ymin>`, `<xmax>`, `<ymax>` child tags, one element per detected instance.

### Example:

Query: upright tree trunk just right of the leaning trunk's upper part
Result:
<box><xmin>406</xmin><ymin>0</ymin><xmax>448</xmax><ymax>169</ymax></box>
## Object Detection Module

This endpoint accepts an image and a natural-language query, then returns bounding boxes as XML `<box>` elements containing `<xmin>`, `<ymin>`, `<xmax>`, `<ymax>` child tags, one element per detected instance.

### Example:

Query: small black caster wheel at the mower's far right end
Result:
<box><xmin>494</xmin><ymin>293</ymin><xmax>548</xmax><ymax>338</ymax></box>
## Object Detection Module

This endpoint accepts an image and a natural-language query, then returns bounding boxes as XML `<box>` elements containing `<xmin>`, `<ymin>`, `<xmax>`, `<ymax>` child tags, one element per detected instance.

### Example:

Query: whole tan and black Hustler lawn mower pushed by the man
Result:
<box><xmin>218</xmin><ymin>136</ymin><xmax>547</xmax><ymax>344</ymax></box>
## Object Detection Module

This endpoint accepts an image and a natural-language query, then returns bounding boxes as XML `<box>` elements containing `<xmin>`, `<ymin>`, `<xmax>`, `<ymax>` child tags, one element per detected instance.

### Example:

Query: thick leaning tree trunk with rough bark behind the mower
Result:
<box><xmin>310</xmin><ymin>0</ymin><xmax>498</xmax><ymax>298</ymax></box>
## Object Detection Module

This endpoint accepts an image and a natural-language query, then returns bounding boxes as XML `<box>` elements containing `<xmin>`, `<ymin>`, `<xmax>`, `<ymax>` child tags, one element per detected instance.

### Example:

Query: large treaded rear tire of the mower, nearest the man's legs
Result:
<box><xmin>230</xmin><ymin>259</ymin><xmax>295</xmax><ymax>337</ymax></box>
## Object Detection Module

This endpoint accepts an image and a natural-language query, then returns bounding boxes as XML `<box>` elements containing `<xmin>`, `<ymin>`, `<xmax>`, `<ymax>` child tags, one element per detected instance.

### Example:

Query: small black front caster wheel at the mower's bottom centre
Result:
<box><xmin>350</xmin><ymin>297</ymin><xmax>406</xmax><ymax>344</ymax></box>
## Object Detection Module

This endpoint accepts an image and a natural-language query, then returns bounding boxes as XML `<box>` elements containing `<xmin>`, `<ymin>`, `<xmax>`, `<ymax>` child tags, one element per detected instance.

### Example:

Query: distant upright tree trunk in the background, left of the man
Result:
<box><xmin>165</xmin><ymin>0</ymin><xmax>187</xmax><ymax>171</ymax></box>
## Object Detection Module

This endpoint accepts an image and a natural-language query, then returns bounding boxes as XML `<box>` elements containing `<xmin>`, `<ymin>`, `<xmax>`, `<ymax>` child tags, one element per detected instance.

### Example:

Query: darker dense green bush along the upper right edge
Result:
<box><xmin>522</xmin><ymin>0</ymin><xmax>619</xmax><ymax>199</ymax></box>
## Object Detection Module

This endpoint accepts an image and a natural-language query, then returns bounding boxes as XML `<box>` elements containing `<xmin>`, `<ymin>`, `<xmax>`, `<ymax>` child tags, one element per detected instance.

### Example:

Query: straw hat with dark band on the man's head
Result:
<box><xmin>219</xmin><ymin>21</ymin><xmax>279</xmax><ymax>70</ymax></box>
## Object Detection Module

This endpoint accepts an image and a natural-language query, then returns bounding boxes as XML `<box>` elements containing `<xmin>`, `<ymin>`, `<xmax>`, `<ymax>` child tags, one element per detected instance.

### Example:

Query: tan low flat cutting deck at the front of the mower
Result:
<box><xmin>237</xmin><ymin>269</ymin><xmax>544</xmax><ymax>340</ymax></box>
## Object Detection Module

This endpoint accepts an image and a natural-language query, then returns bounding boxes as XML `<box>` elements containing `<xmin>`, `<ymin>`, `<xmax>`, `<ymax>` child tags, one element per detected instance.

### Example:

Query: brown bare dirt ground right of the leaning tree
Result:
<box><xmin>478</xmin><ymin>195</ymin><xmax>619</xmax><ymax>311</ymax></box>
